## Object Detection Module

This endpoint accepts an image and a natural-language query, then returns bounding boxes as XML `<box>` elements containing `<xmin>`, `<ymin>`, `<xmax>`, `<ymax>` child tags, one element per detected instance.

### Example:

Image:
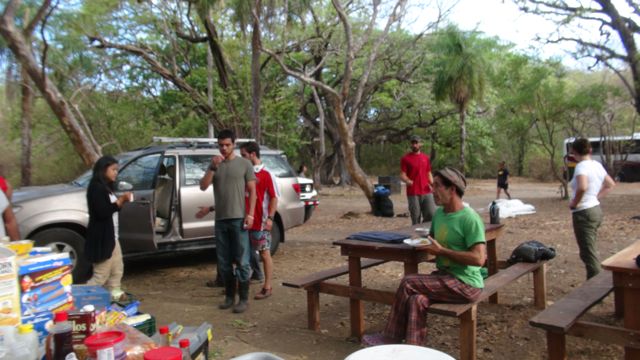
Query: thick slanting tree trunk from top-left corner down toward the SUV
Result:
<box><xmin>0</xmin><ymin>3</ymin><xmax>100</xmax><ymax>166</ymax></box>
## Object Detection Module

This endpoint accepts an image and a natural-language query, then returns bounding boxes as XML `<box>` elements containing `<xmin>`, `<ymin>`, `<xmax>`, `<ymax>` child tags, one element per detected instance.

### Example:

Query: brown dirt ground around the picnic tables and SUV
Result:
<box><xmin>124</xmin><ymin>178</ymin><xmax>640</xmax><ymax>359</ymax></box>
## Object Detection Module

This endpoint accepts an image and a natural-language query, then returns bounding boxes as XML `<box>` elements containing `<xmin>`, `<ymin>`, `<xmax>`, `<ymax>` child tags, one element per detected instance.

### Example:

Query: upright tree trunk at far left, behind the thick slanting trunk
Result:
<box><xmin>20</xmin><ymin>70</ymin><xmax>33</xmax><ymax>186</ymax></box>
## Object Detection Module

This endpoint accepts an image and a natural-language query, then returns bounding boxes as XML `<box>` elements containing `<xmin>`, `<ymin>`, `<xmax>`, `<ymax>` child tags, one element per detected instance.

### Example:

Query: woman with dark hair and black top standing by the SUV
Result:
<box><xmin>85</xmin><ymin>155</ymin><xmax>133</xmax><ymax>299</ymax></box>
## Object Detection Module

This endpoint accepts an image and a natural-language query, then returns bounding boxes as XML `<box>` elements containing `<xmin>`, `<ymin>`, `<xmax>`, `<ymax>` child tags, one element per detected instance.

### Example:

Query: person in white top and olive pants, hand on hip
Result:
<box><xmin>569</xmin><ymin>138</ymin><xmax>615</xmax><ymax>279</ymax></box>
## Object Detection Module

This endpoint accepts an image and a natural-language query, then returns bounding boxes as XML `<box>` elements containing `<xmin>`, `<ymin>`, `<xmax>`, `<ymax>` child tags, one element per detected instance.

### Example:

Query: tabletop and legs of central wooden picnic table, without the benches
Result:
<box><xmin>330</xmin><ymin>224</ymin><xmax>504</xmax><ymax>338</ymax></box>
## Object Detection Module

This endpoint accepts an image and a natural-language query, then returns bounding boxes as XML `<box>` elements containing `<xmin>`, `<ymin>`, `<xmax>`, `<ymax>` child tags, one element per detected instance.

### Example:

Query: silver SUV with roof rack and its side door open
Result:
<box><xmin>13</xmin><ymin>138</ymin><xmax>305</xmax><ymax>281</ymax></box>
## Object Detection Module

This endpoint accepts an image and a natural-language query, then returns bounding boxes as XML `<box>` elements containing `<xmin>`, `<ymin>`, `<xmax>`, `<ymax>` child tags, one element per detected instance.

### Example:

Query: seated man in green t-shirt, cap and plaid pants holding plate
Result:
<box><xmin>363</xmin><ymin>167</ymin><xmax>487</xmax><ymax>346</ymax></box>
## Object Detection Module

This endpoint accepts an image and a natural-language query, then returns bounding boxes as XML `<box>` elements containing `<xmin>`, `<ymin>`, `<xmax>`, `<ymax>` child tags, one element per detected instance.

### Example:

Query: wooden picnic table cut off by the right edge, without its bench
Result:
<box><xmin>602</xmin><ymin>240</ymin><xmax>640</xmax><ymax>360</ymax></box>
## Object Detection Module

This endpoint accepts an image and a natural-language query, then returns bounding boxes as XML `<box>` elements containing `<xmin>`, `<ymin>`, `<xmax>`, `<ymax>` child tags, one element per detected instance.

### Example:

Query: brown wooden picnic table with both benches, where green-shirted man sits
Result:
<box><xmin>283</xmin><ymin>224</ymin><xmax>546</xmax><ymax>360</ymax></box>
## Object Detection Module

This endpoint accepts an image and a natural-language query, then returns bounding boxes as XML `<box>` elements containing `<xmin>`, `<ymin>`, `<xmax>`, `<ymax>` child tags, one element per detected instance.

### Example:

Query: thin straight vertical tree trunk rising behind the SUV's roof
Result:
<box><xmin>251</xmin><ymin>0</ymin><xmax>262</xmax><ymax>144</ymax></box>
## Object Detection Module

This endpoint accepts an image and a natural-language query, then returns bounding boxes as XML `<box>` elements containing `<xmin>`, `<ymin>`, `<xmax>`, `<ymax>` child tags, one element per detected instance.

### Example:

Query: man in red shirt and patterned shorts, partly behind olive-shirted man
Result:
<box><xmin>240</xmin><ymin>141</ymin><xmax>279</xmax><ymax>300</ymax></box>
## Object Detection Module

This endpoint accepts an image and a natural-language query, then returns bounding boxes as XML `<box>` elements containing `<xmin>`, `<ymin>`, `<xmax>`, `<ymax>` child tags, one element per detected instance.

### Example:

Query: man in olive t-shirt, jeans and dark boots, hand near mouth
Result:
<box><xmin>198</xmin><ymin>130</ymin><xmax>256</xmax><ymax>313</ymax></box>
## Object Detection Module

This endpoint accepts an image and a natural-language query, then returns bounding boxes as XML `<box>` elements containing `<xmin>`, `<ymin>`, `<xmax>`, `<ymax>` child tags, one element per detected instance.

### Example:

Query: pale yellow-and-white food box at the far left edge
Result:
<box><xmin>0</xmin><ymin>247</ymin><xmax>20</xmax><ymax>326</ymax></box>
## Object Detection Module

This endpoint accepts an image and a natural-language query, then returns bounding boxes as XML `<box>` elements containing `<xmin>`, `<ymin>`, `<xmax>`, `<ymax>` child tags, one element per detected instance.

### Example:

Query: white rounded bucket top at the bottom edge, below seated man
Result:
<box><xmin>345</xmin><ymin>345</ymin><xmax>455</xmax><ymax>360</ymax></box>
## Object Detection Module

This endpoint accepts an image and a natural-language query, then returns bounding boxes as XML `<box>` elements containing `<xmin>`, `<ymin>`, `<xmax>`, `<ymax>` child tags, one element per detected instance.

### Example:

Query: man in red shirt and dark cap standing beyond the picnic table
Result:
<box><xmin>400</xmin><ymin>135</ymin><xmax>436</xmax><ymax>225</ymax></box>
